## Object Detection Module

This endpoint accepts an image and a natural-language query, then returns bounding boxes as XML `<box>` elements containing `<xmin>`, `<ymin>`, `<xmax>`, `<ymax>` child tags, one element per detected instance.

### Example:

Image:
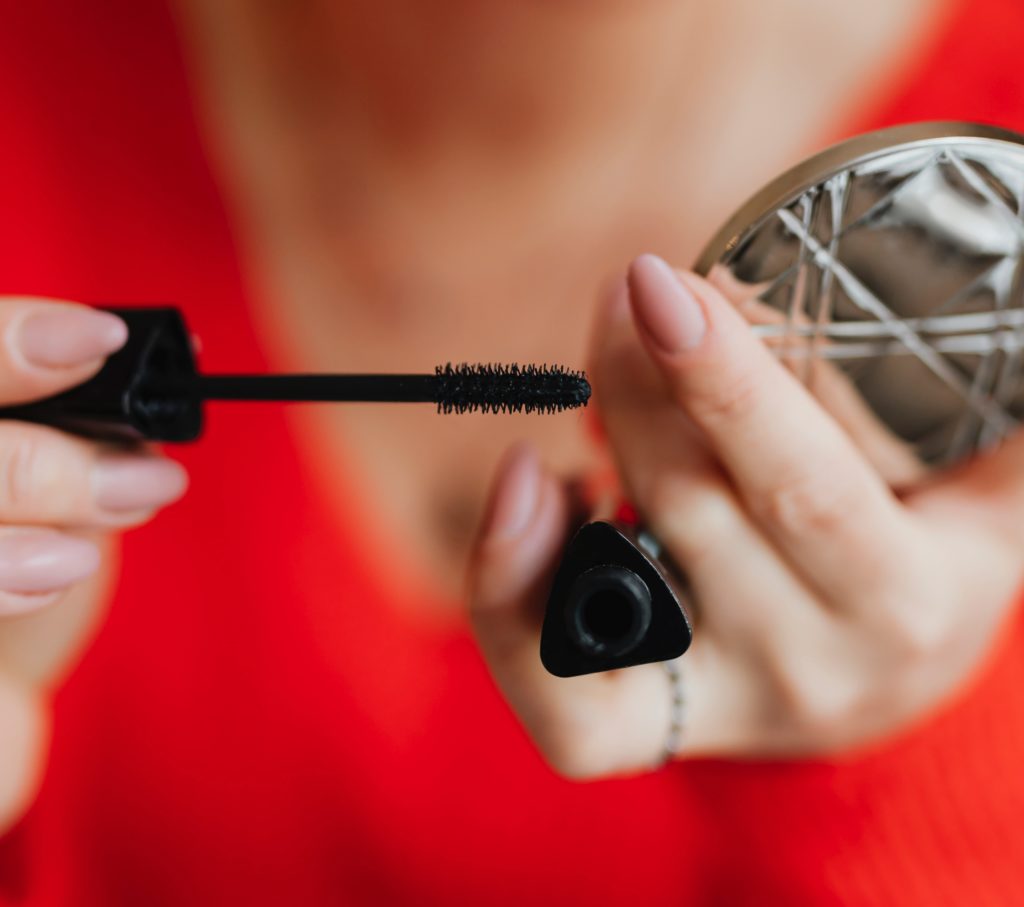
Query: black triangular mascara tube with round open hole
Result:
<box><xmin>541</xmin><ymin>520</ymin><xmax>693</xmax><ymax>677</ymax></box>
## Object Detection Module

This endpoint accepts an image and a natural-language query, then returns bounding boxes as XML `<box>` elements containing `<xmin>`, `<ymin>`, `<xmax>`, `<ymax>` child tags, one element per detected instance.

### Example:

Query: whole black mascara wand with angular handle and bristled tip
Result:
<box><xmin>0</xmin><ymin>307</ymin><xmax>590</xmax><ymax>441</ymax></box>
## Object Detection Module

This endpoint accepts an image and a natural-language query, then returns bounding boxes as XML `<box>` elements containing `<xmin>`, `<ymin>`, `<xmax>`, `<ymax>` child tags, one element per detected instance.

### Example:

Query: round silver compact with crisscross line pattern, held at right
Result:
<box><xmin>696</xmin><ymin>124</ymin><xmax>1024</xmax><ymax>468</ymax></box>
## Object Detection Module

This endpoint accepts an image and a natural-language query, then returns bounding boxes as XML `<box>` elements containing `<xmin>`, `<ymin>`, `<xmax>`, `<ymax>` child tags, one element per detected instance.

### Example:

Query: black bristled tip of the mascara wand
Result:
<box><xmin>435</xmin><ymin>362</ymin><xmax>590</xmax><ymax>413</ymax></box>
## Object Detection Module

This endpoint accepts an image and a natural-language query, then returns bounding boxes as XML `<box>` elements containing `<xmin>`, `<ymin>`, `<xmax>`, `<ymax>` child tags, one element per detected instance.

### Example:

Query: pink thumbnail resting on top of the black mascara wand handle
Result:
<box><xmin>14</xmin><ymin>305</ymin><xmax>128</xmax><ymax>369</ymax></box>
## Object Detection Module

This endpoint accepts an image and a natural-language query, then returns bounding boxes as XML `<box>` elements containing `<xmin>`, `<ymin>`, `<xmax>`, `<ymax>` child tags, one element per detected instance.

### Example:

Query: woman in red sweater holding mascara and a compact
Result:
<box><xmin>0</xmin><ymin>0</ymin><xmax>1024</xmax><ymax>904</ymax></box>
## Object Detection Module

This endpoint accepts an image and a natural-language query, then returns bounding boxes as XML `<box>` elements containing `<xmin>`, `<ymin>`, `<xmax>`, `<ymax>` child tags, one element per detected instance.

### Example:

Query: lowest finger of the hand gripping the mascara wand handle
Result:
<box><xmin>0</xmin><ymin>526</ymin><xmax>100</xmax><ymax>619</ymax></box>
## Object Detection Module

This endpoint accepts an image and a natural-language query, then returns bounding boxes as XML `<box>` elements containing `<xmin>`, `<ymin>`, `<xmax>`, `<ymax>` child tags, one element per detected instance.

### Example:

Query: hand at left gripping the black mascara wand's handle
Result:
<box><xmin>0</xmin><ymin>297</ymin><xmax>187</xmax><ymax>832</ymax></box>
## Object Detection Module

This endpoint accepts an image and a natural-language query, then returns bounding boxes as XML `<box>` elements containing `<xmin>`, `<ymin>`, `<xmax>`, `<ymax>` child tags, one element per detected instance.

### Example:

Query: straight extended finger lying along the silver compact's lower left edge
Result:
<box><xmin>630</xmin><ymin>256</ymin><xmax>913</xmax><ymax>604</ymax></box>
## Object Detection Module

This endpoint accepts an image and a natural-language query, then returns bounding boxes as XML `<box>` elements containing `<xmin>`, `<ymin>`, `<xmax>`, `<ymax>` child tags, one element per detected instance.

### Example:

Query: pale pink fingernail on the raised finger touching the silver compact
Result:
<box><xmin>629</xmin><ymin>255</ymin><xmax>708</xmax><ymax>353</ymax></box>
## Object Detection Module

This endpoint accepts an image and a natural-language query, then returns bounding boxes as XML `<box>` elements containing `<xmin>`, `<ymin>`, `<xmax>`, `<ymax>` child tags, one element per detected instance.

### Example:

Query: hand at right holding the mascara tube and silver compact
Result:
<box><xmin>471</xmin><ymin>256</ymin><xmax>1024</xmax><ymax>778</ymax></box>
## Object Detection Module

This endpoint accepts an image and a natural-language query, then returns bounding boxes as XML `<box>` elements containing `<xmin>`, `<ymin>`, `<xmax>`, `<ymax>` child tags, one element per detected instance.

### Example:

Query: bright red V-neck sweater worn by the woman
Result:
<box><xmin>0</xmin><ymin>0</ymin><xmax>1024</xmax><ymax>907</ymax></box>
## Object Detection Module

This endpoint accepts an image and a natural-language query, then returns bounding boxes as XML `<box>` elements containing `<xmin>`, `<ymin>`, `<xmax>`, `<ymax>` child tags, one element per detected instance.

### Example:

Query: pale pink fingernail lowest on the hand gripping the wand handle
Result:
<box><xmin>0</xmin><ymin>528</ymin><xmax>99</xmax><ymax>594</ymax></box>
